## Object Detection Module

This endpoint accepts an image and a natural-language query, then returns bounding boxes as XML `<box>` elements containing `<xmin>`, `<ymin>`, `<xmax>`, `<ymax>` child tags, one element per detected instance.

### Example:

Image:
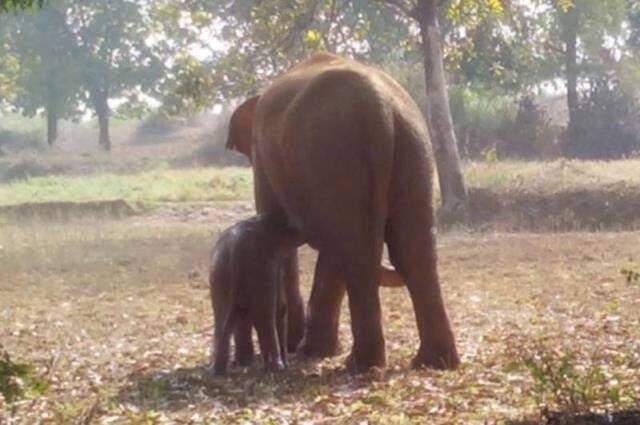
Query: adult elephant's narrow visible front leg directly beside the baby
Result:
<box><xmin>284</xmin><ymin>250</ymin><xmax>305</xmax><ymax>353</ymax></box>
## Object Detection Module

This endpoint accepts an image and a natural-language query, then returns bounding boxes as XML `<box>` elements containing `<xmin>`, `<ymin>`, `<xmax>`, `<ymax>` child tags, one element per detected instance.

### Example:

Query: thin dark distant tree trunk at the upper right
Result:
<box><xmin>563</xmin><ymin>6</ymin><xmax>578</xmax><ymax>149</ymax></box>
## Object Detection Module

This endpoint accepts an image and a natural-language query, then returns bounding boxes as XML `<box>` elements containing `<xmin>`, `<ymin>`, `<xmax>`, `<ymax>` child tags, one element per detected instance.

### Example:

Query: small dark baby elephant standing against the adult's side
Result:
<box><xmin>209</xmin><ymin>215</ymin><xmax>301</xmax><ymax>375</ymax></box>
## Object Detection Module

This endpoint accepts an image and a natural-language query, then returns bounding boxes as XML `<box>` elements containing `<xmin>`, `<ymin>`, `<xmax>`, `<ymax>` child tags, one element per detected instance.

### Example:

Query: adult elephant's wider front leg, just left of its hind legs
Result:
<box><xmin>299</xmin><ymin>252</ymin><xmax>345</xmax><ymax>357</ymax></box>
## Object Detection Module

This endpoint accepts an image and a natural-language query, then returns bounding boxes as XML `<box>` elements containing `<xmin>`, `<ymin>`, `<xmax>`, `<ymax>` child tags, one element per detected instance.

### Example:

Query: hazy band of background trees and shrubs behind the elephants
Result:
<box><xmin>0</xmin><ymin>0</ymin><xmax>640</xmax><ymax>159</ymax></box>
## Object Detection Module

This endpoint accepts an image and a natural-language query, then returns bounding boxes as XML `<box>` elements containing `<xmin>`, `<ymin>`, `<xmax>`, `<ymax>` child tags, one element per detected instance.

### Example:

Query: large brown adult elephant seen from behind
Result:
<box><xmin>228</xmin><ymin>54</ymin><xmax>459</xmax><ymax>370</ymax></box>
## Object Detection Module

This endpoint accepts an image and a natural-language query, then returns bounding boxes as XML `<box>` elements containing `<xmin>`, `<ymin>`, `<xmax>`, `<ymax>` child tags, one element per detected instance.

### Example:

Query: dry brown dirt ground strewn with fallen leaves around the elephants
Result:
<box><xmin>0</xmin><ymin>202</ymin><xmax>640</xmax><ymax>424</ymax></box>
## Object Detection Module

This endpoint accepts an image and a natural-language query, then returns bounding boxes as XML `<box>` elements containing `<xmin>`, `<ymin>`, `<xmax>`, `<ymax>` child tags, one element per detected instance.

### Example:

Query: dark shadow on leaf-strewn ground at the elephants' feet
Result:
<box><xmin>114</xmin><ymin>357</ymin><xmax>388</xmax><ymax>412</ymax></box>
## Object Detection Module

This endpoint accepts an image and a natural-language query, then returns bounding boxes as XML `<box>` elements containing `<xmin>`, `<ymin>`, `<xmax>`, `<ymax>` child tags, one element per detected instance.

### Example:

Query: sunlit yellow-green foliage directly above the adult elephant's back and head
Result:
<box><xmin>164</xmin><ymin>0</ymin><xmax>419</xmax><ymax>113</ymax></box>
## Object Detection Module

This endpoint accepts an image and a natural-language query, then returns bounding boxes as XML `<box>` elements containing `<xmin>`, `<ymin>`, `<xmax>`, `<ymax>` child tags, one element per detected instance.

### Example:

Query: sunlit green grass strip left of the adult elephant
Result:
<box><xmin>0</xmin><ymin>167</ymin><xmax>253</xmax><ymax>205</ymax></box>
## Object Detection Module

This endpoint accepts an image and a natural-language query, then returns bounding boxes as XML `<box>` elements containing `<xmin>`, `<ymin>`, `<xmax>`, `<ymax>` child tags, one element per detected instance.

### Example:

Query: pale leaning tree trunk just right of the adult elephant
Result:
<box><xmin>415</xmin><ymin>0</ymin><xmax>467</xmax><ymax>222</ymax></box>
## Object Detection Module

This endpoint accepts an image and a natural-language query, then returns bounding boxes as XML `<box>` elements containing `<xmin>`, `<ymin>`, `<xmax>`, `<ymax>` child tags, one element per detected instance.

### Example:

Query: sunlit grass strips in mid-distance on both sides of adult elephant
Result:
<box><xmin>0</xmin><ymin>159</ymin><xmax>640</xmax><ymax>205</ymax></box>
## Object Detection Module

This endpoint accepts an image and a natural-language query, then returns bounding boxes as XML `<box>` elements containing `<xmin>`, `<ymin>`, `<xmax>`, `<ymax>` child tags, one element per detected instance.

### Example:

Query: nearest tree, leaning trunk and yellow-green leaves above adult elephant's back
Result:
<box><xmin>169</xmin><ymin>0</ymin><xmax>500</xmax><ymax>216</ymax></box>
